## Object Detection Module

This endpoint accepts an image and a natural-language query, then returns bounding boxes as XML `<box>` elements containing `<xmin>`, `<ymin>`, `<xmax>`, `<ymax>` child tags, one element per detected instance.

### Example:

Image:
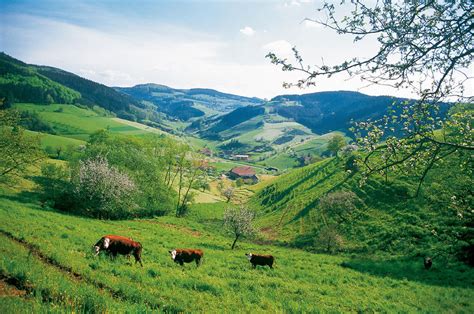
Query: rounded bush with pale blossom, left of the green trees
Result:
<box><xmin>72</xmin><ymin>156</ymin><xmax>136</xmax><ymax>219</ymax></box>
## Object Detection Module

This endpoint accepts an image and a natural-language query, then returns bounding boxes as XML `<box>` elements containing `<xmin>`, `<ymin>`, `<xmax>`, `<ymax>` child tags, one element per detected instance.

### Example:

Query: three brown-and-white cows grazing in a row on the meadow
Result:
<box><xmin>94</xmin><ymin>235</ymin><xmax>275</xmax><ymax>269</ymax></box>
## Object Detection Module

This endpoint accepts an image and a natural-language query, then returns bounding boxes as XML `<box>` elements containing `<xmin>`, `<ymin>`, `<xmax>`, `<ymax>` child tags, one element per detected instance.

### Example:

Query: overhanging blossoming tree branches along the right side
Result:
<box><xmin>267</xmin><ymin>0</ymin><xmax>474</xmax><ymax>194</ymax></box>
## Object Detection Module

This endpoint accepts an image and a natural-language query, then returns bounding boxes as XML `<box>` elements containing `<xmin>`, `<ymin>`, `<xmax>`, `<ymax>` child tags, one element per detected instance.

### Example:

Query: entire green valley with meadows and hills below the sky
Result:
<box><xmin>0</xmin><ymin>49</ymin><xmax>474</xmax><ymax>313</ymax></box>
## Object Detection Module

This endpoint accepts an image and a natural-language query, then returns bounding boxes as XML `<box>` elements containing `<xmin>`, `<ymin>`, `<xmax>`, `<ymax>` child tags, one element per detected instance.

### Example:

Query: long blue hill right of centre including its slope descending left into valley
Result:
<box><xmin>193</xmin><ymin>91</ymin><xmax>403</xmax><ymax>138</ymax></box>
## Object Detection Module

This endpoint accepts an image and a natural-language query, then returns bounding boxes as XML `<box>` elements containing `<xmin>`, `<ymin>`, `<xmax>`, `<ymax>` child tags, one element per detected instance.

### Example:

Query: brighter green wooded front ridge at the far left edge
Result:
<box><xmin>0</xmin><ymin>52</ymin><xmax>81</xmax><ymax>104</ymax></box>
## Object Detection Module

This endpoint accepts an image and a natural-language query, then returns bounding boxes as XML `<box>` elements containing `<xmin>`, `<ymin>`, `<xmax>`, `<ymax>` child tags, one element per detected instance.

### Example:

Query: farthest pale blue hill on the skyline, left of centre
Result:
<box><xmin>115</xmin><ymin>84</ymin><xmax>262</xmax><ymax>121</ymax></box>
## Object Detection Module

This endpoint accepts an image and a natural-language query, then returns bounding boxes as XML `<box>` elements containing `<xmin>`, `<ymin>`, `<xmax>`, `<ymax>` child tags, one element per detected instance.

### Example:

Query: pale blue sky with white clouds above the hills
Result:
<box><xmin>0</xmin><ymin>0</ymin><xmax>442</xmax><ymax>98</ymax></box>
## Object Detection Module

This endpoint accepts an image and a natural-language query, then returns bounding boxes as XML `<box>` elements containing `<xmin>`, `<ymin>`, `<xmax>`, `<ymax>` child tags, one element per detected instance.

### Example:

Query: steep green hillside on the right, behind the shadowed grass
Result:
<box><xmin>251</xmin><ymin>153</ymin><xmax>469</xmax><ymax>255</ymax></box>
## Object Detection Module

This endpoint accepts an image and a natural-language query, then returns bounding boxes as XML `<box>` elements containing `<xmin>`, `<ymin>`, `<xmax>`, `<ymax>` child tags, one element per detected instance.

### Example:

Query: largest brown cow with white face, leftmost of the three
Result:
<box><xmin>94</xmin><ymin>235</ymin><xmax>143</xmax><ymax>267</ymax></box>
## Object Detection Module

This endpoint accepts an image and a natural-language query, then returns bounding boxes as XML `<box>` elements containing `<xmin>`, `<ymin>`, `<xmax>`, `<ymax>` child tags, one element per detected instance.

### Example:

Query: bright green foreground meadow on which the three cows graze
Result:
<box><xmin>0</xmin><ymin>194</ymin><xmax>474</xmax><ymax>312</ymax></box>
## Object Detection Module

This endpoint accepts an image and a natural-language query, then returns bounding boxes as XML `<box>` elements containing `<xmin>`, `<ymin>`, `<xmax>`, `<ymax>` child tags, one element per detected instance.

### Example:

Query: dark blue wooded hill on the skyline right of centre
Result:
<box><xmin>272</xmin><ymin>91</ymin><xmax>402</xmax><ymax>134</ymax></box>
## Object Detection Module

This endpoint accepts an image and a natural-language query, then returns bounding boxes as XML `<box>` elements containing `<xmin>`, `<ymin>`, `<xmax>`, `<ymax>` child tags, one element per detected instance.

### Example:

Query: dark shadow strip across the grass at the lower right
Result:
<box><xmin>341</xmin><ymin>257</ymin><xmax>474</xmax><ymax>289</ymax></box>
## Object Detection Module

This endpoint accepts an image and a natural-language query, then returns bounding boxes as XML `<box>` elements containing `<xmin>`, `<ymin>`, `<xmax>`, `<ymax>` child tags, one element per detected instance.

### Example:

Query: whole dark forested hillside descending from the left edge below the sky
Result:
<box><xmin>0</xmin><ymin>53</ymin><xmax>142</xmax><ymax>118</ymax></box>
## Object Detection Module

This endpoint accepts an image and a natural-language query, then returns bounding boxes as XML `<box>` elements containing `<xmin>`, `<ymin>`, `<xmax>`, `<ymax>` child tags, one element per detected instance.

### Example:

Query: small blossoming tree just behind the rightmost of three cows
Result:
<box><xmin>224</xmin><ymin>205</ymin><xmax>255</xmax><ymax>250</ymax></box>
